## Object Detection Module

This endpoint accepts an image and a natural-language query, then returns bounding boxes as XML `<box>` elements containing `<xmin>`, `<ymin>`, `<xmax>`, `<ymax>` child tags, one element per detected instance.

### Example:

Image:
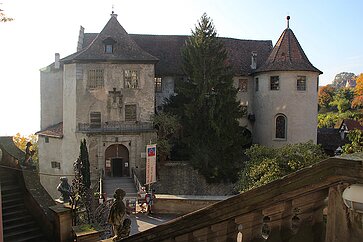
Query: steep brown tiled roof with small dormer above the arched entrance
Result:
<box><xmin>72</xmin><ymin>14</ymin><xmax>158</xmax><ymax>63</ymax></box>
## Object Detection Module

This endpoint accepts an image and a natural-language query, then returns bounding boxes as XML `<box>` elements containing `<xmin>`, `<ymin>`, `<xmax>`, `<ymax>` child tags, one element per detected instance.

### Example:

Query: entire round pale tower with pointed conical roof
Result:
<box><xmin>253</xmin><ymin>16</ymin><xmax>322</xmax><ymax>147</ymax></box>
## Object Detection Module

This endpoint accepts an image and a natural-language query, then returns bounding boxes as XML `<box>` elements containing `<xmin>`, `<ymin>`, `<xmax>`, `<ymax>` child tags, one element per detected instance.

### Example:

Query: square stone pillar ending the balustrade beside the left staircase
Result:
<box><xmin>49</xmin><ymin>204</ymin><xmax>73</xmax><ymax>242</ymax></box>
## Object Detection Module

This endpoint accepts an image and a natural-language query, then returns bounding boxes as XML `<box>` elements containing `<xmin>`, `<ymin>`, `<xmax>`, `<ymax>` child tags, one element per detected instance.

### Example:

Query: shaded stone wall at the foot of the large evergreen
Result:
<box><xmin>153</xmin><ymin>162</ymin><xmax>233</xmax><ymax>196</ymax></box>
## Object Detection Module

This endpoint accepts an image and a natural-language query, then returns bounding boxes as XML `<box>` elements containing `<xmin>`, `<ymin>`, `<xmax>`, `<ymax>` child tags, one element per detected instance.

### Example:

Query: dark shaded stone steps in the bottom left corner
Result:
<box><xmin>0</xmin><ymin>169</ymin><xmax>47</xmax><ymax>242</ymax></box>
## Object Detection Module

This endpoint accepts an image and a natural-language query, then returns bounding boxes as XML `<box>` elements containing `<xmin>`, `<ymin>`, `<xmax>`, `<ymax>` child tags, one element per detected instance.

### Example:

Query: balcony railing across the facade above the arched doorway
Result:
<box><xmin>78</xmin><ymin>122</ymin><xmax>154</xmax><ymax>133</ymax></box>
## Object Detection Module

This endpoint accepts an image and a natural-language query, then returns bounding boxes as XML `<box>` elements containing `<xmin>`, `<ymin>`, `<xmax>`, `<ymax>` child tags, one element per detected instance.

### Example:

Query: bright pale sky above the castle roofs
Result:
<box><xmin>0</xmin><ymin>0</ymin><xmax>363</xmax><ymax>136</ymax></box>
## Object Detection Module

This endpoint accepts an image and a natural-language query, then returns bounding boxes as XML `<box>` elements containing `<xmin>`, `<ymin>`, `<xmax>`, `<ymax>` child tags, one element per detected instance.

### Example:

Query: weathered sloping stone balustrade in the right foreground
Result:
<box><xmin>123</xmin><ymin>158</ymin><xmax>363</xmax><ymax>242</ymax></box>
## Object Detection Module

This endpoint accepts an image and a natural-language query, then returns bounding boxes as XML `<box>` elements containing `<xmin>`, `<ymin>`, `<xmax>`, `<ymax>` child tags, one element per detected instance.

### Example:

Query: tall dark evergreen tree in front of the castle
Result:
<box><xmin>167</xmin><ymin>14</ymin><xmax>250</xmax><ymax>182</ymax></box>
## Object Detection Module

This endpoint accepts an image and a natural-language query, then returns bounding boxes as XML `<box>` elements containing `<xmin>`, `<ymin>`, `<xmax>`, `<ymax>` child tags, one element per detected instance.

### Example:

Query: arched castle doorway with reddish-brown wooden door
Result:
<box><xmin>105</xmin><ymin>144</ymin><xmax>130</xmax><ymax>177</ymax></box>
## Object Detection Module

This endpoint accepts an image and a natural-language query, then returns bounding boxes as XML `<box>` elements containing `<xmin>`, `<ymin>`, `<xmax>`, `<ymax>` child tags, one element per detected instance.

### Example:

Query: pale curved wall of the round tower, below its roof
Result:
<box><xmin>253</xmin><ymin>71</ymin><xmax>318</xmax><ymax>147</ymax></box>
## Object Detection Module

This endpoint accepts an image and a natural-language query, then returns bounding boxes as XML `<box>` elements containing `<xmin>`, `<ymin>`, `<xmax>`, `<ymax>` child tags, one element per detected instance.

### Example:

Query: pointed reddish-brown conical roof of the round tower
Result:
<box><xmin>255</xmin><ymin>16</ymin><xmax>322</xmax><ymax>74</ymax></box>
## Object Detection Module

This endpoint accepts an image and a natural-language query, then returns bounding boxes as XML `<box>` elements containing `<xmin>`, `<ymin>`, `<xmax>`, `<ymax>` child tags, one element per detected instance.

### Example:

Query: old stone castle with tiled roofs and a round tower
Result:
<box><xmin>38</xmin><ymin>14</ymin><xmax>322</xmax><ymax>197</ymax></box>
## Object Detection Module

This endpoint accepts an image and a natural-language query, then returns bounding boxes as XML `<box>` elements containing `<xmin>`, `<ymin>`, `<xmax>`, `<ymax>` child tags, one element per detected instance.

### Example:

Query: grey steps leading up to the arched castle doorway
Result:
<box><xmin>103</xmin><ymin>177</ymin><xmax>137</xmax><ymax>199</ymax></box>
